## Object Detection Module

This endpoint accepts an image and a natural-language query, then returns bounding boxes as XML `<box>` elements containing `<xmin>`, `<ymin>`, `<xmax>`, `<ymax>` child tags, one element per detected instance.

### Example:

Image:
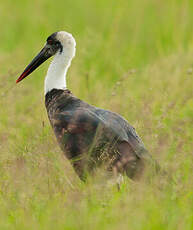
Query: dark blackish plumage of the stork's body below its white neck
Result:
<box><xmin>45</xmin><ymin>89</ymin><xmax>150</xmax><ymax>179</ymax></box>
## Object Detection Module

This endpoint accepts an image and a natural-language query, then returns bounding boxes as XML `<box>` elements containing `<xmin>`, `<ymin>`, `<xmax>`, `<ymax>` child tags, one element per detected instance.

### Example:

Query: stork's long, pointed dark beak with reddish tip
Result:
<box><xmin>16</xmin><ymin>44</ymin><xmax>52</xmax><ymax>83</ymax></box>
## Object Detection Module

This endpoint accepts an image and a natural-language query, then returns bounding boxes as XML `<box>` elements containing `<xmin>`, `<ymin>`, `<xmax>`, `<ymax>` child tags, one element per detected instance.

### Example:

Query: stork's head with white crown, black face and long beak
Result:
<box><xmin>16</xmin><ymin>31</ymin><xmax>76</xmax><ymax>83</ymax></box>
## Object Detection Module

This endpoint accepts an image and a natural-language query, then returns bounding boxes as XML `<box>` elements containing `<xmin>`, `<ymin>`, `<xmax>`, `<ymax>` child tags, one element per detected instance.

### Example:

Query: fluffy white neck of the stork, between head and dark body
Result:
<box><xmin>44</xmin><ymin>48</ymin><xmax>75</xmax><ymax>95</ymax></box>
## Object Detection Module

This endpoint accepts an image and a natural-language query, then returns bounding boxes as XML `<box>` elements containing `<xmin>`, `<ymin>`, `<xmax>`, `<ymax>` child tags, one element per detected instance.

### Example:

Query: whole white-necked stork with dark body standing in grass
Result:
<box><xmin>16</xmin><ymin>31</ymin><xmax>155</xmax><ymax>180</ymax></box>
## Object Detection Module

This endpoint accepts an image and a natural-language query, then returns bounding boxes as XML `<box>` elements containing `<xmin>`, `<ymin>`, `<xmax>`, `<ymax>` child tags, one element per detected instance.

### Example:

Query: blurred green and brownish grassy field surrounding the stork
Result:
<box><xmin>0</xmin><ymin>0</ymin><xmax>193</xmax><ymax>230</ymax></box>
